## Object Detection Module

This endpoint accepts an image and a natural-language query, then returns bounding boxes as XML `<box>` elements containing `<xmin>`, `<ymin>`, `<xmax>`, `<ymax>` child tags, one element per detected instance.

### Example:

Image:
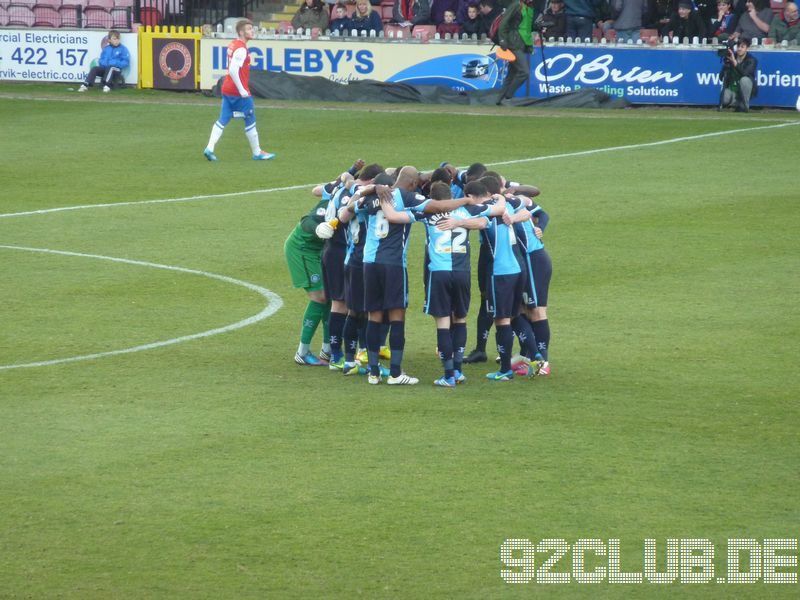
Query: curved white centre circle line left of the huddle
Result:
<box><xmin>0</xmin><ymin>245</ymin><xmax>283</xmax><ymax>371</ymax></box>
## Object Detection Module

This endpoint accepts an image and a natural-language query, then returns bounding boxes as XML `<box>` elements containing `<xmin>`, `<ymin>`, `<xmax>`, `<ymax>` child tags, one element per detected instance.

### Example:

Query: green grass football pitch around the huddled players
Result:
<box><xmin>0</xmin><ymin>84</ymin><xmax>800</xmax><ymax>599</ymax></box>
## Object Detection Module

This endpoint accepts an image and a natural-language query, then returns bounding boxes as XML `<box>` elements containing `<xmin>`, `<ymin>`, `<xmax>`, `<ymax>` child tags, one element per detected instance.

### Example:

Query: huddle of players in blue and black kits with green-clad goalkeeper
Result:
<box><xmin>284</xmin><ymin>160</ymin><xmax>552</xmax><ymax>387</ymax></box>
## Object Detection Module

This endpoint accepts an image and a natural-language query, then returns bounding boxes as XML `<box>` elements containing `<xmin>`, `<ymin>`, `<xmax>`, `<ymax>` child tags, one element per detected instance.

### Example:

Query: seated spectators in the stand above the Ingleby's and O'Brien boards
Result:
<box><xmin>292</xmin><ymin>0</ymin><xmax>800</xmax><ymax>45</ymax></box>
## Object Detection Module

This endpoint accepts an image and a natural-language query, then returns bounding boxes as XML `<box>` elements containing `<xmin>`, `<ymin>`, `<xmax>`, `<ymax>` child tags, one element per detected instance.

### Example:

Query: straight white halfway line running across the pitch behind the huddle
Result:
<box><xmin>0</xmin><ymin>121</ymin><xmax>800</xmax><ymax>219</ymax></box>
